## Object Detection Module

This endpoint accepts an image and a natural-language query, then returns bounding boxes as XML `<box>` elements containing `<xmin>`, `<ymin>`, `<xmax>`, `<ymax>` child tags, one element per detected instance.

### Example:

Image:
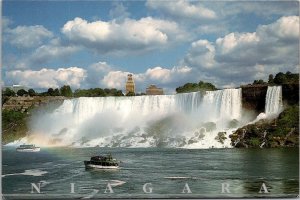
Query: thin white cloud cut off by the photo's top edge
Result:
<box><xmin>146</xmin><ymin>0</ymin><xmax>217</xmax><ymax>20</ymax></box>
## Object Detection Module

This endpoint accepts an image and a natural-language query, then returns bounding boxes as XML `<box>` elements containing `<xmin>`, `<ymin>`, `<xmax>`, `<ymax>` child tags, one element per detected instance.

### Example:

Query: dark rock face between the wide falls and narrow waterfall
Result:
<box><xmin>242</xmin><ymin>85</ymin><xmax>268</xmax><ymax>113</ymax></box>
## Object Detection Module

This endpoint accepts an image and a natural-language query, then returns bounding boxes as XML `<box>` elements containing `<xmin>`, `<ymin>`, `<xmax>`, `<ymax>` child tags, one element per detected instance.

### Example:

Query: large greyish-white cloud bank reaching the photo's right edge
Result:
<box><xmin>182</xmin><ymin>16</ymin><xmax>299</xmax><ymax>86</ymax></box>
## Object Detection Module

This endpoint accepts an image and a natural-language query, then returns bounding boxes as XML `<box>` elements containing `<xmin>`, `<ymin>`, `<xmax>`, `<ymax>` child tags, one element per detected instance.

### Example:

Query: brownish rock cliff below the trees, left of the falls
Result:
<box><xmin>2</xmin><ymin>96</ymin><xmax>67</xmax><ymax>112</ymax></box>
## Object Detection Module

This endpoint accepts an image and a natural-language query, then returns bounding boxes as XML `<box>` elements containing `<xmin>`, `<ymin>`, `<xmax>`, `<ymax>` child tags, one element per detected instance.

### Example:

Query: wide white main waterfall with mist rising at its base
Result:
<box><xmin>24</xmin><ymin>89</ymin><xmax>241</xmax><ymax>148</ymax></box>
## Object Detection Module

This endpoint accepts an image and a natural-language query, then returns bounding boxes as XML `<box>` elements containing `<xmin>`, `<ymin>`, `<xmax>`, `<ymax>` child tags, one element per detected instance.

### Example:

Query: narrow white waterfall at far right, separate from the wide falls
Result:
<box><xmin>265</xmin><ymin>86</ymin><xmax>282</xmax><ymax>116</ymax></box>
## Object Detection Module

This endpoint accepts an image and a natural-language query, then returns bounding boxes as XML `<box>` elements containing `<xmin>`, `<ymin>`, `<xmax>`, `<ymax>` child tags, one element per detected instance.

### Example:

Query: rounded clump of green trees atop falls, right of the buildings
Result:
<box><xmin>176</xmin><ymin>81</ymin><xmax>217</xmax><ymax>93</ymax></box>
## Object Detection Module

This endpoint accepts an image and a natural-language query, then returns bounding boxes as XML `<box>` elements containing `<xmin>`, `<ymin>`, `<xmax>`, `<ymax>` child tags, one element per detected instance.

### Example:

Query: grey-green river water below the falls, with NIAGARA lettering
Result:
<box><xmin>2</xmin><ymin>146</ymin><xmax>299</xmax><ymax>199</ymax></box>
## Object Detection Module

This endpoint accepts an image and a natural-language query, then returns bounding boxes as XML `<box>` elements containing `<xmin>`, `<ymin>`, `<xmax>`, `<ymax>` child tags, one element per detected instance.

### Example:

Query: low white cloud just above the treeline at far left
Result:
<box><xmin>5</xmin><ymin>67</ymin><xmax>86</xmax><ymax>88</ymax></box>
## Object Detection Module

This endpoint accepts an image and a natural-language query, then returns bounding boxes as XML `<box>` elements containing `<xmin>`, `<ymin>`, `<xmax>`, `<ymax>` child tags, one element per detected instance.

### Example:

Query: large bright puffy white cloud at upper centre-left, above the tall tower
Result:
<box><xmin>62</xmin><ymin>17</ymin><xmax>187</xmax><ymax>54</ymax></box>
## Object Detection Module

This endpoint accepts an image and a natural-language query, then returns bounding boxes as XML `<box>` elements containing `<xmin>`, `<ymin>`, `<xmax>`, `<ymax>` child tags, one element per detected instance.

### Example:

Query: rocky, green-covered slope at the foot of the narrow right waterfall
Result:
<box><xmin>229</xmin><ymin>106</ymin><xmax>299</xmax><ymax>148</ymax></box>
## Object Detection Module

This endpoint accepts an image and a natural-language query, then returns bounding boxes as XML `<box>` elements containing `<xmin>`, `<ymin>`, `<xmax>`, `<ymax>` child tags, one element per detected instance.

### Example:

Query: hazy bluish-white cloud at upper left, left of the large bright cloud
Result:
<box><xmin>4</xmin><ymin>25</ymin><xmax>53</xmax><ymax>48</ymax></box>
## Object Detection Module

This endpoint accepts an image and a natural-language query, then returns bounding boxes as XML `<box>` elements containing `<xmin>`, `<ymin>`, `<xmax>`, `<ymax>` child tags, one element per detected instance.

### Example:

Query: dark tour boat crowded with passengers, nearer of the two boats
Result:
<box><xmin>84</xmin><ymin>154</ymin><xmax>119</xmax><ymax>169</ymax></box>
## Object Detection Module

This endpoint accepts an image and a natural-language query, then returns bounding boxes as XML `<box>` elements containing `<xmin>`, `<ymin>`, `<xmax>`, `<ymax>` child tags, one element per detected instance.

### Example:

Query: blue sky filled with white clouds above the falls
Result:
<box><xmin>1</xmin><ymin>0</ymin><xmax>299</xmax><ymax>94</ymax></box>
